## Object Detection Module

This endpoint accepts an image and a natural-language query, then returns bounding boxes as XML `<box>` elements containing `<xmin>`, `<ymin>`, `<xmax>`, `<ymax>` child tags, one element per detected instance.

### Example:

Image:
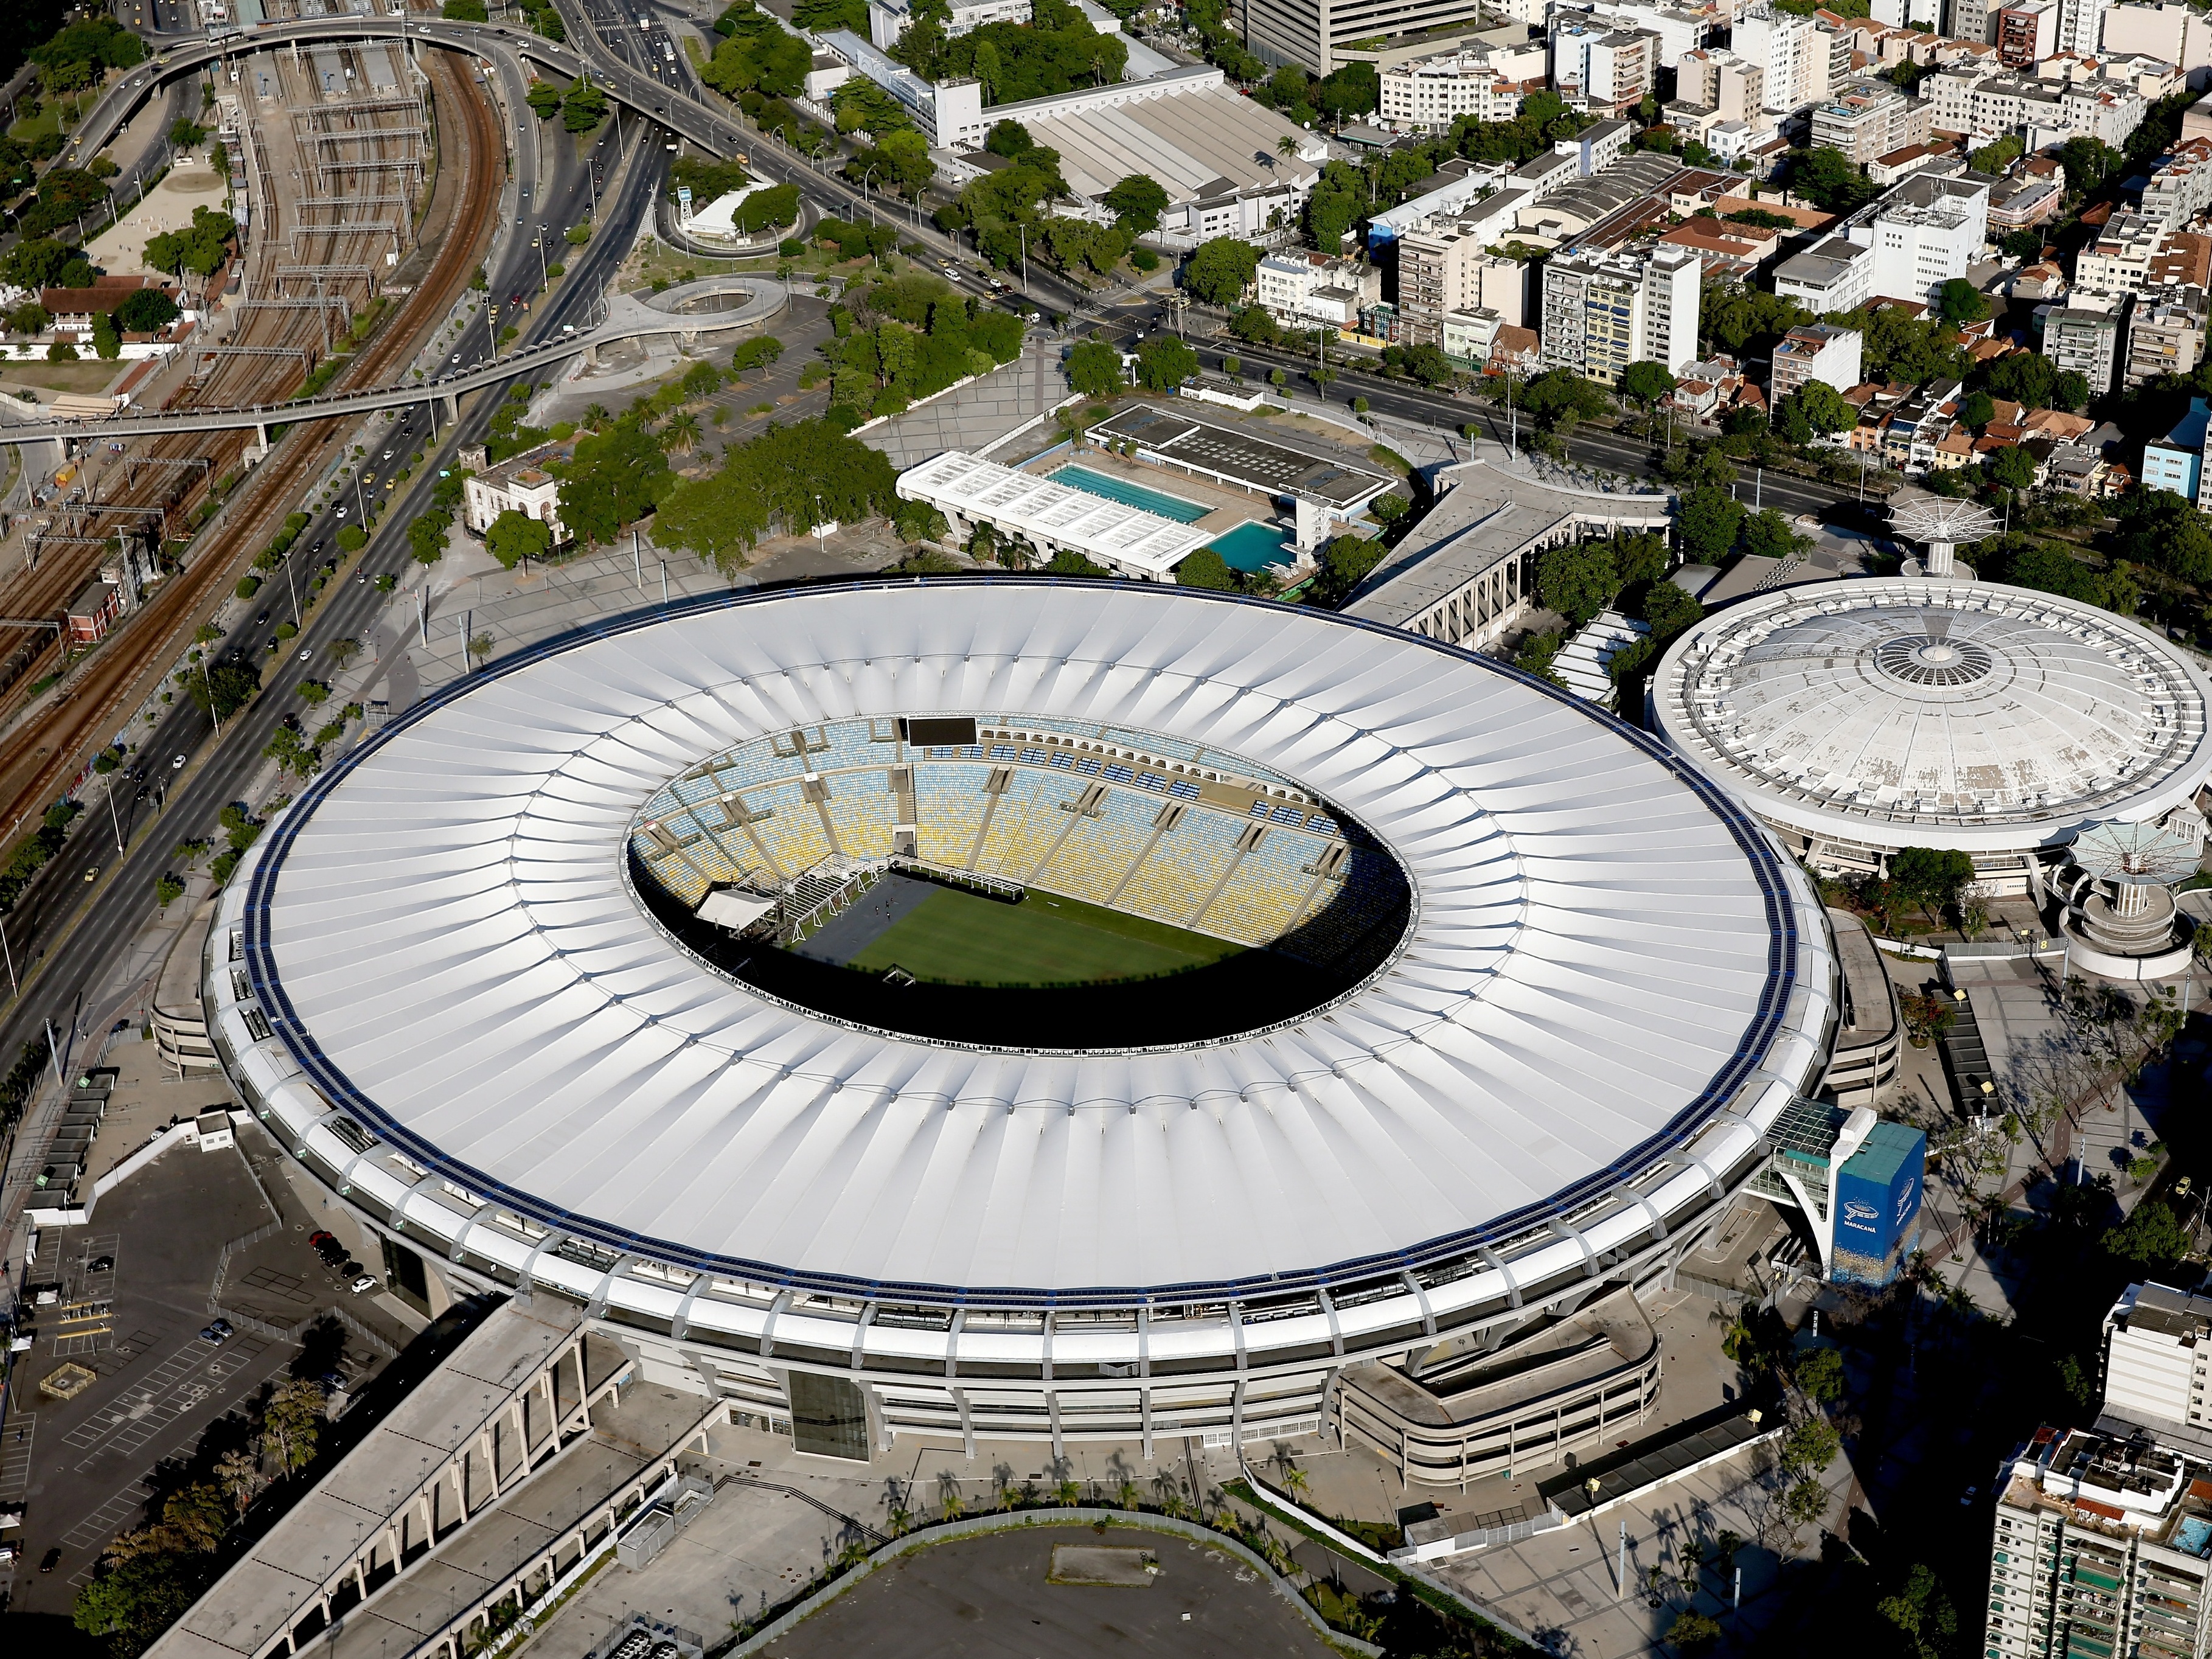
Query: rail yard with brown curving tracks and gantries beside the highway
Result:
<box><xmin>0</xmin><ymin>42</ymin><xmax>507</xmax><ymax>849</ymax></box>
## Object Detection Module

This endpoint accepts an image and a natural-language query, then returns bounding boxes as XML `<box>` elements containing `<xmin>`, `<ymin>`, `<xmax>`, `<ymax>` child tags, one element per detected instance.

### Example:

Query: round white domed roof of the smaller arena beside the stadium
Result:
<box><xmin>1652</xmin><ymin>577</ymin><xmax>2212</xmax><ymax>854</ymax></box>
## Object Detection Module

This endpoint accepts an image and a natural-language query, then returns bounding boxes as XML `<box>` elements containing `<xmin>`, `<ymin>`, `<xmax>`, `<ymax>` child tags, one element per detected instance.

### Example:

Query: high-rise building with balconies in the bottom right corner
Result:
<box><xmin>1982</xmin><ymin>1427</ymin><xmax>2212</xmax><ymax>1659</ymax></box>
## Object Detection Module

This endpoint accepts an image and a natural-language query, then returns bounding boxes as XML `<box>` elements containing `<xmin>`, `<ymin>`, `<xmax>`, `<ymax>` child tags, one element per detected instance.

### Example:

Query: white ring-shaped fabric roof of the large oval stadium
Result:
<box><xmin>224</xmin><ymin>593</ymin><xmax>1834</xmax><ymax>1305</ymax></box>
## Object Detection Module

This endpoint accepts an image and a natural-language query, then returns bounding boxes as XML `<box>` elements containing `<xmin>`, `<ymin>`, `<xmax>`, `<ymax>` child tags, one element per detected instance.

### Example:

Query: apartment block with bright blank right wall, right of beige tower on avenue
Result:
<box><xmin>1542</xmin><ymin>246</ymin><xmax>1701</xmax><ymax>385</ymax></box>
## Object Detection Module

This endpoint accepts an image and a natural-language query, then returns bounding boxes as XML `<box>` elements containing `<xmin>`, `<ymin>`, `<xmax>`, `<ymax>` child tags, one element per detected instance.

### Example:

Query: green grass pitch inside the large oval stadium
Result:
<box><xmin>852</xmin><ymin>887</ymin><xmax>1245</xmax><ymax>984</ymax></box>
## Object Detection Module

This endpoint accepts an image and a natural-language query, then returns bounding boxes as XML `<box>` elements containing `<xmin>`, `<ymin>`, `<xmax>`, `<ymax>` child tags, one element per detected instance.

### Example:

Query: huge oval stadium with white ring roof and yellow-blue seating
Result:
<box><xmin>204</xmin><ymin>577</ymin><xmax>1838</xmax><ymax>1480</ymax></box>
